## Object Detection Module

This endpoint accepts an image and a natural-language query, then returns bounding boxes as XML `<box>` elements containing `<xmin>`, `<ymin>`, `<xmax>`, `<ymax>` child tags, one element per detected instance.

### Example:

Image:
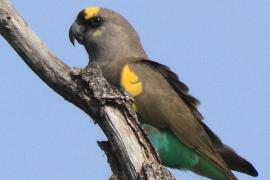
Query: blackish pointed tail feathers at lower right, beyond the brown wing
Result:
<box><xmin>200</xmin><ymin>121</ymin><xmax>258</xmax><ymax>177</ymax></box>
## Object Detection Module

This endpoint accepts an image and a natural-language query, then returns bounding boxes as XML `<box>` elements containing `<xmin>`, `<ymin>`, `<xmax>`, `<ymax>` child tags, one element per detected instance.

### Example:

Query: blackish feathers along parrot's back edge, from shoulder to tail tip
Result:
<box><xmin>137</xmin><ymin>60</ymin><xmax>258</xmax><ymax>176</ymax></box>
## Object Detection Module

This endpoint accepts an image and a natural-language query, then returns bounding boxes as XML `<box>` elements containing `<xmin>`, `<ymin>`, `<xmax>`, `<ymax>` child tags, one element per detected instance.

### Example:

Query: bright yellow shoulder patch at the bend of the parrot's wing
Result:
<box><xmin>120</xmin><ymin>64</ymin><xmax>143</xmax><ymax>97</ymax></box>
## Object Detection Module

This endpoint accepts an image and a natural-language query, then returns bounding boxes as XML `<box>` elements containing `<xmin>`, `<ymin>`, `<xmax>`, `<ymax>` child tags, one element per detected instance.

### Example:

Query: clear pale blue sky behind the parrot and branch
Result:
<box><xmin>0</xmin><ymin>0</ymin><xmax>270</xmax><ymax>180</ymax></box>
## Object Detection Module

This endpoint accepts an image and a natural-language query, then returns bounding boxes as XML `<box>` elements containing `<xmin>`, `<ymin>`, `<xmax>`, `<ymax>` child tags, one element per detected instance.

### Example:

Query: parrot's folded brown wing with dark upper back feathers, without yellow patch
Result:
<box><xmin>126</xmin><ymin>60</ymin><xmax>234</xmax><ymax>179</ymax></box>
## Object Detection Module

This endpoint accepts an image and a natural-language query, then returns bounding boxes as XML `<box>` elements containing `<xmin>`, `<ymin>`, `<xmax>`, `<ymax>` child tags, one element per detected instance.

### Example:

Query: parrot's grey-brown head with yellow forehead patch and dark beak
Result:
<box><xmin>69</xmin><ymin>7</ymin><xmax>146</xmax><ymax>61</ymax></box>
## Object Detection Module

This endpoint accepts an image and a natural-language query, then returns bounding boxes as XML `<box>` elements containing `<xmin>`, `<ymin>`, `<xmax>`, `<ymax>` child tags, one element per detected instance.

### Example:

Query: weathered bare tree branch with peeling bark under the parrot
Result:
<box><xmin>0</xmin><ymin>0</ymin><xmax>174</xmax><ymax>180</ymax></box>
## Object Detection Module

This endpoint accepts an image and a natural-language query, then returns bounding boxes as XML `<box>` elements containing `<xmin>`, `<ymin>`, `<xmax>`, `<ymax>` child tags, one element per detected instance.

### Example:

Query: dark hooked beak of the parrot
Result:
<box><xmin>69</xmin><ymin>22</ymin><xmax>84</xmax><ymax>46</ymax></box>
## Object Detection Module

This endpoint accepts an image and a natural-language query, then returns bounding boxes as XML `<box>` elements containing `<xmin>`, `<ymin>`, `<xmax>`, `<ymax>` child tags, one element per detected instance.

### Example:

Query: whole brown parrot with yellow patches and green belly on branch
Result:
<box><xmin>69</xmin><ymin>6</ymin><xmax>258</xmax><ymax>180</ymax></box>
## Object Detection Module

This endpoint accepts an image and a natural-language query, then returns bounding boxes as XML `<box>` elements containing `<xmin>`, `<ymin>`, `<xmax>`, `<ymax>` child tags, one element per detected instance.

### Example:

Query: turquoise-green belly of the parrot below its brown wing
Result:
<box><xmin>142</xmin><ymin>124</ymin><xmax>229</xmax><ymax>180</ymax></box>
